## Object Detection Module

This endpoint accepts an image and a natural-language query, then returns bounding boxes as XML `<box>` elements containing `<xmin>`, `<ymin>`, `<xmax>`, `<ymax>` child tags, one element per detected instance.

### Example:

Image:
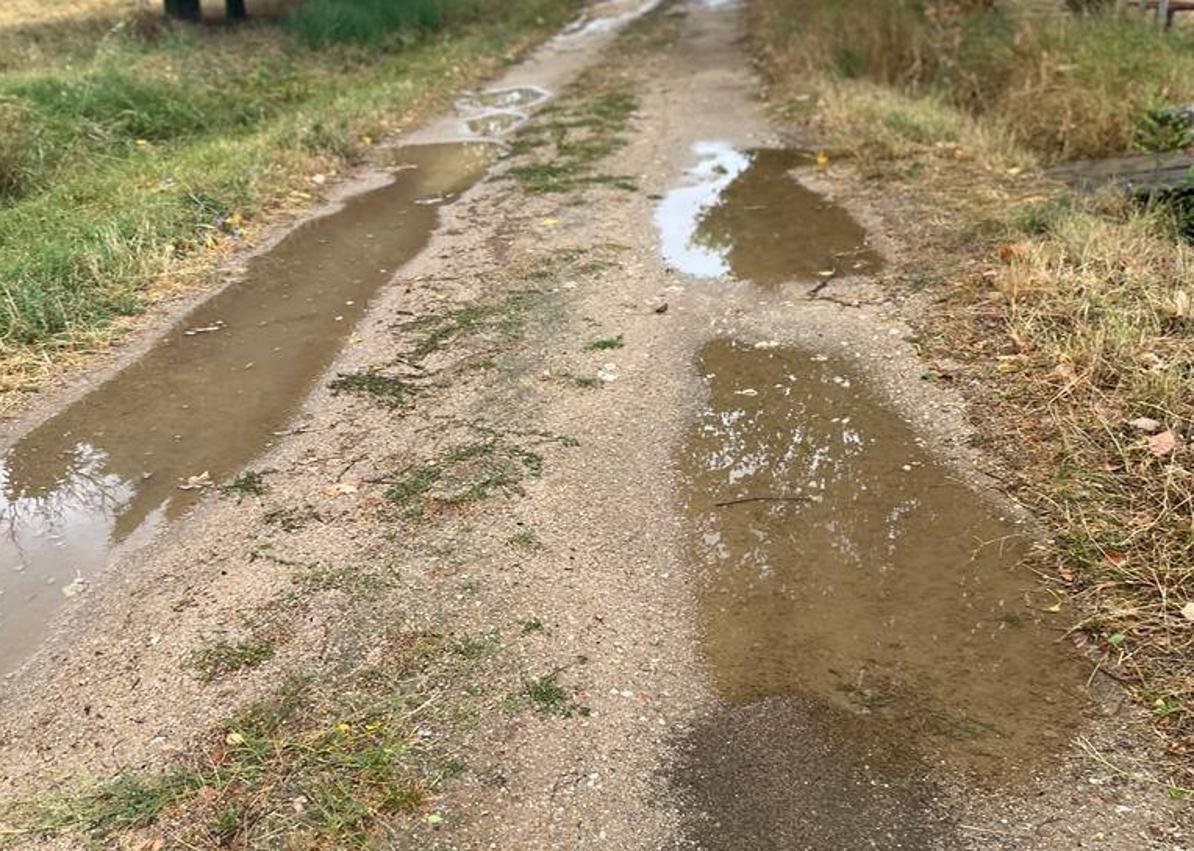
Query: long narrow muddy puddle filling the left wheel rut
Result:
<box><xmin>0</xmin><ymin>144</ymin><xmax>493</xmax><ymax>672</ymax></box>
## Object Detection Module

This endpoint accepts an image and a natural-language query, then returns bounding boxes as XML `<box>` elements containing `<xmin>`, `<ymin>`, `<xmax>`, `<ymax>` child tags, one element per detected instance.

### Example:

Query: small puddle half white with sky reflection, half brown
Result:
<box><xmin>654</xmin><ymin>142</ymin><xmax>882</xmax><ymax>285</ymax></box>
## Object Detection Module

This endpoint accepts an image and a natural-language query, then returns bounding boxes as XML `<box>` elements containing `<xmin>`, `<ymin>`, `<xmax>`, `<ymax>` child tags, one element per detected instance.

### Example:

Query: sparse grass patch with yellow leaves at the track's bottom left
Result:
<box><xmin>4</xmin><ymin>634</ymin><xmax>488</xmax><ymax>849</ymax></box>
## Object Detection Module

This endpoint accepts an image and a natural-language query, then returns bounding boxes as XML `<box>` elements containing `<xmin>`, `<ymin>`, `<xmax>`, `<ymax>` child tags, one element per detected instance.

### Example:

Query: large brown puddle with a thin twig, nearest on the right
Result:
<box><xmin>678</xmin><ymin>340</ymin><xmax>1089</xmax><ymax>785</ymax></box>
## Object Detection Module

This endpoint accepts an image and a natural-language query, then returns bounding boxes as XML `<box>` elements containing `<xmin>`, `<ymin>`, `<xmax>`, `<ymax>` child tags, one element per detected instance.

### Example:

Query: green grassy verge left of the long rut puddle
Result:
<box><xmin>0</xmin><ymin>0</ymin><xmax>577</xmax><ymax>398</ymax></box>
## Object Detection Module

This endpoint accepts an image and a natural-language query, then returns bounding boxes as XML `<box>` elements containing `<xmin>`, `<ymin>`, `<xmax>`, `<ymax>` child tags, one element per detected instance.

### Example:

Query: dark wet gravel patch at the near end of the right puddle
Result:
<box><xmin>675</xmin><ymin>698</ymin><xmax>958</xmax><ymax>851</ymax></box>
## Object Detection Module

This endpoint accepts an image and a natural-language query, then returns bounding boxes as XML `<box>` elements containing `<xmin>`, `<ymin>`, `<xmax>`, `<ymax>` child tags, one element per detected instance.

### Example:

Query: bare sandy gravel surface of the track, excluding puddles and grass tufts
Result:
<box><xmin>0</xmin><ymin>0</ymin><xmax>1194</xmax><ymax>851</ymax></box>
